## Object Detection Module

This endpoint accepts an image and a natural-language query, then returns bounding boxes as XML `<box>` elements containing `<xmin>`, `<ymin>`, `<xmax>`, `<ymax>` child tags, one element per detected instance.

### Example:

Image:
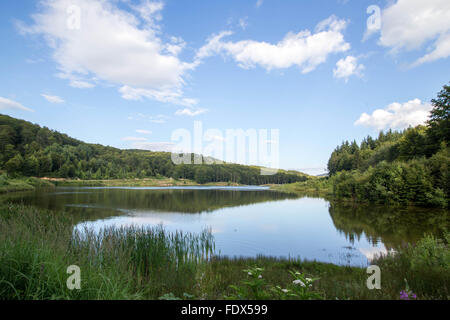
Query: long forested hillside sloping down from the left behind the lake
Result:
<box><xmin>0</xmin><ymin>115</ymin><xmax>307</xmax><ymax>185</ymax></box>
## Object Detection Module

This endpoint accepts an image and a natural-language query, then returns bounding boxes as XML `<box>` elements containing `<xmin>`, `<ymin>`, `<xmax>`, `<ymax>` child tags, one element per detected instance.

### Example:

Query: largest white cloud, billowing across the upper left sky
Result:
<box><xmin>19</xmin><ymin>0</ymin><xmax>195</xmax><ymax>105</ymax></box>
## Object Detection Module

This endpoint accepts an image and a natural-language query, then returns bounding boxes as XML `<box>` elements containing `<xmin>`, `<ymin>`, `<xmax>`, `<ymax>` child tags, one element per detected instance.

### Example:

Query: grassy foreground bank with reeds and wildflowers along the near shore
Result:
<box><xmin>0</xmin><ymin>205</ymin><xmax>450</xmax><ymax>300</ymax></box>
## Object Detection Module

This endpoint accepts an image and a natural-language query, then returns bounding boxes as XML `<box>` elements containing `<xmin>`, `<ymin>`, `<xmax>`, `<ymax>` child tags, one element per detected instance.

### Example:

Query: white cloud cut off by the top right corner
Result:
<box><xmin>370</xmin><ymin>0</ymin><xmax>450</xmax><ymax>66</ymax></box>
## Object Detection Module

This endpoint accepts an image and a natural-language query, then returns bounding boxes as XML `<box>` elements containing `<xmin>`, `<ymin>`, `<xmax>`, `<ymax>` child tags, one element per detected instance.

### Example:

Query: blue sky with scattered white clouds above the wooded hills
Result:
<box><xmin>0</xmin><ymin>0</ymin><xmax>450</xmax><ymax>174</ymax></box>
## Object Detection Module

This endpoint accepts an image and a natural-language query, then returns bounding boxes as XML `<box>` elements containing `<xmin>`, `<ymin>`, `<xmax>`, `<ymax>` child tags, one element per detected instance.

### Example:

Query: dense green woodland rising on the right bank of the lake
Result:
<box><xmin>328</xmin><ymin>85</ymin><xmax>450</xmax><ymax>207</ymax></box>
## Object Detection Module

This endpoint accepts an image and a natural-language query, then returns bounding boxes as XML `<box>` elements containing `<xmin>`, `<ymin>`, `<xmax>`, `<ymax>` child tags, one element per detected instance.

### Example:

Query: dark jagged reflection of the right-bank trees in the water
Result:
<box><xmin>329</xmin><ymin>202</ymin><xmax>449</xmax><ymax>249</ymax></box>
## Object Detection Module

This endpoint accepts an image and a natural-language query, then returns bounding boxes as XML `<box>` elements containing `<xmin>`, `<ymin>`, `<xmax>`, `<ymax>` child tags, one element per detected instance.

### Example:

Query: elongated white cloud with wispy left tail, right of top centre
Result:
<box><xmin>197</xmin><ymin>16</ymin><xmax>350</xmax><ymax>73</ymax></box>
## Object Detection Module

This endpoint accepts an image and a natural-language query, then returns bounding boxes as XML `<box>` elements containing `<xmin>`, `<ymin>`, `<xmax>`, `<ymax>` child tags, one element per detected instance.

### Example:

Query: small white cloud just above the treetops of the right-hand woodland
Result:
<box><xmin>355</xmin><ymin>99</ymin><xmax>433</xmax><ymax>130</ymax></box>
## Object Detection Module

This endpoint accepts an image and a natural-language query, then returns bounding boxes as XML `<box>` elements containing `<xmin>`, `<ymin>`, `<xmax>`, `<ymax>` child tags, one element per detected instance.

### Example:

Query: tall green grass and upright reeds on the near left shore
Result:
<box><xmin>0</xmin><ymin>206</ymin><xmax>214</xmax><ymax>299</ymax></box>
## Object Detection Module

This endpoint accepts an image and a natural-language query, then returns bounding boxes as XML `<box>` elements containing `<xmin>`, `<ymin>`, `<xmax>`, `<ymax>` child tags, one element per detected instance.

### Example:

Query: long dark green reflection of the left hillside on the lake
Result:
<box><xmin>5</xmin><ymin>189</ymin><xmax>297</xmax><ymax>224</ymax></box>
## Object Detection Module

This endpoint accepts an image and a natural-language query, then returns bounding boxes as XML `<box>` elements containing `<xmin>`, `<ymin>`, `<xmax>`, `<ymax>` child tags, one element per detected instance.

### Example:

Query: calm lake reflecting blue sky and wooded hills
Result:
<box><xmin>7</xmin><ymin>187</ymin><xmax>449</xmax><ymax>266</ymax></box>
